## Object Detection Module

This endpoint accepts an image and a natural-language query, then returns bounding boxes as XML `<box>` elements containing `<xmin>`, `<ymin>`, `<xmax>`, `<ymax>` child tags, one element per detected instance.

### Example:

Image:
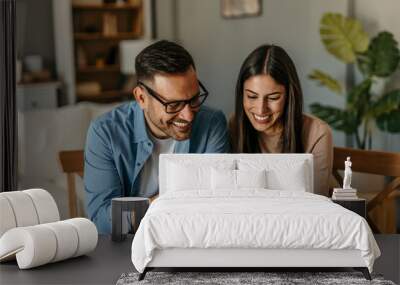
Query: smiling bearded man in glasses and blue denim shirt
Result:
<box><xmin>84</xmin><ymin>41</ymin><xmax>229</xmax><ymax>233</ymax></box>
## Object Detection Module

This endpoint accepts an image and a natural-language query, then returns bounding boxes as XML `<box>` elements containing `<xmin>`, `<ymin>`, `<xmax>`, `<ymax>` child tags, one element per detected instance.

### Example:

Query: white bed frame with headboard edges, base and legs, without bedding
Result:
<box><xmin>139</xmin><ymin>154</ymin><xmax>371</xmax><ymax>280</ymax></box>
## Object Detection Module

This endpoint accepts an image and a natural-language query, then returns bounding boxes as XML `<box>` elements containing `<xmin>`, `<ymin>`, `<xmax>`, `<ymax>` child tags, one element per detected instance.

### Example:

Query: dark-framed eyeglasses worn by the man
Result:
<box><xmin>138</xmin><ymin>81</ymin><xmax>208</xmax><ymax>114</ymax></box>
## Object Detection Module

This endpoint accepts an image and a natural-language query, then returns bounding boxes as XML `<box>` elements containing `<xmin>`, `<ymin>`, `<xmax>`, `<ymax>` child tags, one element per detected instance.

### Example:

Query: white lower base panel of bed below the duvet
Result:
<box><xmin>148</xmin><ymin>248</ymin><xmax>365</xmax><ymax>267</ymax></box>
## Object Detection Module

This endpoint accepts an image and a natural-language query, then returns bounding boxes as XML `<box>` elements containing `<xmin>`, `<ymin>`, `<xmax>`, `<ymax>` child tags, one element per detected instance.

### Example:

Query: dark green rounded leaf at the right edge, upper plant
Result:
<box><xmin>357</xmin><ymin>32</ymin><xmax>400</xmax><ymax>77</ymax></box>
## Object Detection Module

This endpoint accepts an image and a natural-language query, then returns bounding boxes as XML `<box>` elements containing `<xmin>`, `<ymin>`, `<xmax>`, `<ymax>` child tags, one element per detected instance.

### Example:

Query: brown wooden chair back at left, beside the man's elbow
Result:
<box><xmin>58</xmin><ymin>150</ymin><xmax>84</xmax><ymax>218</ymax></box>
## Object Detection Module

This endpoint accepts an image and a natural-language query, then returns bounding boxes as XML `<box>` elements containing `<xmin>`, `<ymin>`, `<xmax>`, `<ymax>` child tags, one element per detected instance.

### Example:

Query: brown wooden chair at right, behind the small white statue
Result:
<box><xmin>332</xmin><ymin>147</ymin><xmax>400</xmax><ymax>233</ymax></box>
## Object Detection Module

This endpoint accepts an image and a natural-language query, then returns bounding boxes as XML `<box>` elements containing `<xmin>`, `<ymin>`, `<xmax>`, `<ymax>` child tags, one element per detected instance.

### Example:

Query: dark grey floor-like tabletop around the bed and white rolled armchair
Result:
<box><xmin>0</xmin><ymin>235</ymin><xmax>400</xmax><ymax>285</ymax></box>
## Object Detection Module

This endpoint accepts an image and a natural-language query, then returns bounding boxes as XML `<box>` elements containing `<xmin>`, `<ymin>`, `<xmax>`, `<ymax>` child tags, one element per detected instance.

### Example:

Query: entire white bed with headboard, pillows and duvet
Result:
<box><xmin>132</xmin><ymin>154</ymin><xmax>380</xmax><ymax>278</ymax></box>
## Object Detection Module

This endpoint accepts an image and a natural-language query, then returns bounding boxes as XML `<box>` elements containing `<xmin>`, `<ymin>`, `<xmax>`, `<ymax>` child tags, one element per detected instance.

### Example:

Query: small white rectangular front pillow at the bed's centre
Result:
<box><xmin>211</xmin><ymin>168</ymin><xmax>267</xmax><ymax>190</ymax></box>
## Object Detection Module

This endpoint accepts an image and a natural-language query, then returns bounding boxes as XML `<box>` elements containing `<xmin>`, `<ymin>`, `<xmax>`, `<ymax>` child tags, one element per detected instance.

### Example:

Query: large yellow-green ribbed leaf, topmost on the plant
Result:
<box><xmin>320</xmin><ymin>13</ymin><xmax>369</xmax><ymax>63</ymax></box>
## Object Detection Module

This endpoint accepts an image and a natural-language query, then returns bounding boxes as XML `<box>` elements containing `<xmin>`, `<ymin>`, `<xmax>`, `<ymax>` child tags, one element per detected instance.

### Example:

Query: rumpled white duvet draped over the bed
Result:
<box><xmin>132</xmin><ymin>189</ymin><xmax>380</xmax><ymax>272</ymax></box>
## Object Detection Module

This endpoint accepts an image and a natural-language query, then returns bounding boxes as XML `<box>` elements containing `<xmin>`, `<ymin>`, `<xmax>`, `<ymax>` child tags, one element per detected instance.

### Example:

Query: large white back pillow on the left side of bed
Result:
<box><xmin>167</xmin><ymin>160</ymin><xmax>235</xmax><ymax>191</ymax></box>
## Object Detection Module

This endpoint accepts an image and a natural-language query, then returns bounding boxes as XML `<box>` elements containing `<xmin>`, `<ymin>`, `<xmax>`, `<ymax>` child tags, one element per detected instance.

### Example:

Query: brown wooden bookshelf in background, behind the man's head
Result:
<box><xmin>72</xmin><ymin>0</ymin><xmax>144</xmax><ymax>103</ymax></box>
